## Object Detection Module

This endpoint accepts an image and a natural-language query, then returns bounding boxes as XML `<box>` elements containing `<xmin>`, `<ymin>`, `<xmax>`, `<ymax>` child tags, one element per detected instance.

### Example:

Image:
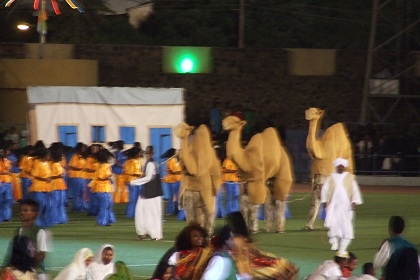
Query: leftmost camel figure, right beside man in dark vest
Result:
<box><xmin>174</xmin><ymin>122</ymin><xmax>221</xmax><ymax>232</ymax></box>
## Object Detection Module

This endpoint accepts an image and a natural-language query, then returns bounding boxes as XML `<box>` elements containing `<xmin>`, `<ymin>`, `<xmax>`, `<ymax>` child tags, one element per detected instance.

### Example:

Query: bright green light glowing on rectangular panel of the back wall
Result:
<box><xmin>162</xmin><ymin>47</ymin><xmax>213</xmax><ymax>74</ymax></box>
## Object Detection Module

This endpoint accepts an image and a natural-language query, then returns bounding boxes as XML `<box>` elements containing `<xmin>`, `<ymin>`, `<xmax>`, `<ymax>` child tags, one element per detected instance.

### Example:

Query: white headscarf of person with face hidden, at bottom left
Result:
<box><xmin>54</xmin><ymin>248</ymin><xmax>93</xmax><ymax>280</ymax></box>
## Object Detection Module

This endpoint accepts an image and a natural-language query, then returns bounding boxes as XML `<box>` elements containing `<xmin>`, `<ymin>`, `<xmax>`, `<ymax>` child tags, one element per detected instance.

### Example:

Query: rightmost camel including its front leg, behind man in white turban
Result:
<box><xmin>305</xmin><ymin>108</ymin><xmax>353</xmax><ymax>231</ymax></box>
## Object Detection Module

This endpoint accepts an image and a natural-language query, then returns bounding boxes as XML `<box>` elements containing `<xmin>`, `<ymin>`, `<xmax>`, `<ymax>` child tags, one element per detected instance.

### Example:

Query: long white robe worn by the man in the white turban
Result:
<box><xmin>321</xmin><ymin>172</ymin><xmax>362</xmax><ymax>239</ymax></box>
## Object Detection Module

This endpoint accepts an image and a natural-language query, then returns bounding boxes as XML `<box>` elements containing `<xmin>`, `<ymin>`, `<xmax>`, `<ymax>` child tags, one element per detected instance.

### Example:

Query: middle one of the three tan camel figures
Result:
<box><xmin>222</xmin><ymin>116</ymin><xmax>293</xmax><ymax>206</ymax></box>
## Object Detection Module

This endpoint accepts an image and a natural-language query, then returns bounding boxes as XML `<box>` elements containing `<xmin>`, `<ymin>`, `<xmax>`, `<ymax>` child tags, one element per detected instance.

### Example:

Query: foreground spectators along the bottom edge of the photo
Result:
<box><xmin>0</xmin><ymin>199</ymin><xmax>419</xmax><ymax>280</ymax></box>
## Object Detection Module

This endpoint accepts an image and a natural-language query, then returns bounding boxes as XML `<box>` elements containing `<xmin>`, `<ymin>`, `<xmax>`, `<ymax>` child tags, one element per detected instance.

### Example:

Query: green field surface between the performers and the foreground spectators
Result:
<box><xmin>0</xmin><ymin>193</ymin><xmax>420</xmax><ymax>279</ymax></box>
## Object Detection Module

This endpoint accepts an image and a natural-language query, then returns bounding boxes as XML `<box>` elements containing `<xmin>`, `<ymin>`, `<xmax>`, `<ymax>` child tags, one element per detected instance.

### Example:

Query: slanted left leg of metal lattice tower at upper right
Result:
<box><xmin>360</xmin><ymin>0</ymin><xmax>379</xmax><ymax>124</ymax></box>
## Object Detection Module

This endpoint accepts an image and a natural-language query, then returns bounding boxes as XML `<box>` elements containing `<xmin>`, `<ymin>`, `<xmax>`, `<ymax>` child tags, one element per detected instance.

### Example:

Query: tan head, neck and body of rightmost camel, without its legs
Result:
<box><xmin>305</xmin><ymin>108</ymin><xmax>353</xmax><ymax>176</ymax></box>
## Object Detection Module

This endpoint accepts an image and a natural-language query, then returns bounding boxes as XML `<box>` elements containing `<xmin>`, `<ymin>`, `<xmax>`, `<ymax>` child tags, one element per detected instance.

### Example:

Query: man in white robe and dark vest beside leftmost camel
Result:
<box><xmin>130</xmin><ymin>146</ymin><xmax>163</xmax><ymax>240</ymax></box>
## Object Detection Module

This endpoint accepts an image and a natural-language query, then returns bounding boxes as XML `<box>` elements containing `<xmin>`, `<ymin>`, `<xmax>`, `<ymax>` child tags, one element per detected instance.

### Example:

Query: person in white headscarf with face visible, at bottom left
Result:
<box><xmin>86</xmin><ymin>244</ymin><xmax>115</xmax><ymax>280</ymax></box>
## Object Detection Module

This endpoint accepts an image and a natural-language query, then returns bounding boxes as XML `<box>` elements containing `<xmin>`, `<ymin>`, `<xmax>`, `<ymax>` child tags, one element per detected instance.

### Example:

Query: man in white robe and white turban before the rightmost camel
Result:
<box><xmin>321</xmin><ymin>158</ymin><xmax>362</xmax><ymax>254</ymax></box>
